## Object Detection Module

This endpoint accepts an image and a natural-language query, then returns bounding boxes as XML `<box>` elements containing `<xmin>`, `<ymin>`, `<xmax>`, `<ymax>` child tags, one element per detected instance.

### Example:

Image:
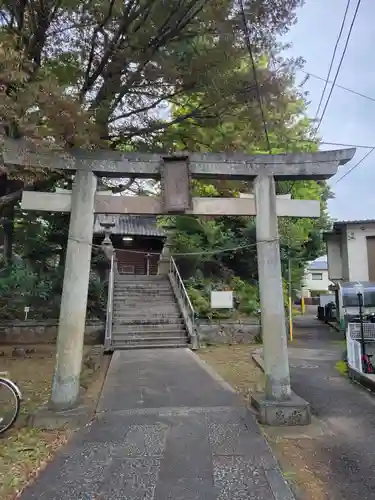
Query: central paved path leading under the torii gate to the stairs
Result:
<box><xmin>21</xmin><ymin>349</ymin><xmax>293</xmax><ymax>500</ymax></box>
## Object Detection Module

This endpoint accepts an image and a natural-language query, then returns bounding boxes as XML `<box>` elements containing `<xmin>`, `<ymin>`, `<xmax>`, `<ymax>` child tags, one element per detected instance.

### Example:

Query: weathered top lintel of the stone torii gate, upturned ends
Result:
<box><xmin>3</xmin><ymin>140</ymin><xmax>356</xmax><ymax>181</ymax></box>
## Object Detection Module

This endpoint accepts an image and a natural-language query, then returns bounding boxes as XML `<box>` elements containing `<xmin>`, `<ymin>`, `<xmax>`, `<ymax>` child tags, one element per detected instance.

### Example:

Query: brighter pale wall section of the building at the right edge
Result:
<box><xmin>346</xmin><ymin>224</ymin><xmax>375</xmax><ymax>281</ymax></box>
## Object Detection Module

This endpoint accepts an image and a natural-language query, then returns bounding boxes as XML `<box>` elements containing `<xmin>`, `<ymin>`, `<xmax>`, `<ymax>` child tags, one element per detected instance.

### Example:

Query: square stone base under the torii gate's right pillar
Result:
<box><xmin>251</xmin><ymin>392</ymin><xmax>311</xmax><ymax>426</ymax></box>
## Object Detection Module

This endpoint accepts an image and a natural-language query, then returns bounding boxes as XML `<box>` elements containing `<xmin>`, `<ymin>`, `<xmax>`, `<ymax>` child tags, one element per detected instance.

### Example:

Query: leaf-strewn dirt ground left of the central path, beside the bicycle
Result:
<box><xmin>0</xmin><ymin>345</ymin><xmax>108</xmax><ymax>500</ymax></box>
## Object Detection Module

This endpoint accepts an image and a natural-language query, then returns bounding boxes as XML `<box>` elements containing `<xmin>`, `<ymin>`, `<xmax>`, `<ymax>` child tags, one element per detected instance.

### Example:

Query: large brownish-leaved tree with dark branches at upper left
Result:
<box><xmin>0</xmin><ymin>0</ymin><xmax>302</xmax><ymax>200</ymax></box>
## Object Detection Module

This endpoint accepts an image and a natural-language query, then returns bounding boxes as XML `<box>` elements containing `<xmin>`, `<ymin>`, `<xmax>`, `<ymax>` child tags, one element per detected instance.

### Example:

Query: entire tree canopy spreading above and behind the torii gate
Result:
<box><xmin>0</xmin><ymin>0</ymin><xmax>329</xmax><ymax>320</ymax></box>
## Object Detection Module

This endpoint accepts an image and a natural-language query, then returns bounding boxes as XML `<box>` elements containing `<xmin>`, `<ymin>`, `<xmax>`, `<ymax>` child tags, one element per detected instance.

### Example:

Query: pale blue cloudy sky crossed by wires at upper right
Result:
<box><xmin>283</xmin><ymin>0</ymin><xmax>375</xmax><ymax>220</ymax></box>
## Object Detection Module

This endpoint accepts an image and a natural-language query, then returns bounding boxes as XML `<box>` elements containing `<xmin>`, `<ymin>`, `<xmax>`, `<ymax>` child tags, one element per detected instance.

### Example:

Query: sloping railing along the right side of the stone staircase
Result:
<box><xmin>169</xmin><ymin>257</ymin><xmax>198</xmax><ymax>349</ymax></box>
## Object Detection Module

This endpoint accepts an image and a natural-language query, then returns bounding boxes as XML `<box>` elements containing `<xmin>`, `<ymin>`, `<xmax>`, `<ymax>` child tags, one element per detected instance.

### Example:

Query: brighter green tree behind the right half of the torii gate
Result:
<box><xmin>153</xmin><ymin>55</ymin><xmax>330</xmax><ymax>308</ymax></box>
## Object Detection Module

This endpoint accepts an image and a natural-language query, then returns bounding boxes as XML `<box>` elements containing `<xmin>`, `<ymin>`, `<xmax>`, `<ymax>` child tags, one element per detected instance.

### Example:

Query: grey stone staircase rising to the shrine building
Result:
<box><xmin>111</xmin><ymin>275</ymin><xmax>188</xmax><ymax>350</ymax></box>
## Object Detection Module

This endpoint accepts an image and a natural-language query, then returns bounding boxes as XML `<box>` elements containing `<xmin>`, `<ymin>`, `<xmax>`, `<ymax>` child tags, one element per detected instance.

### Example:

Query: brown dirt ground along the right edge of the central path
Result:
<box><xmin>198</xmin><ymin>345</ymin><xmax>328</xmax><ymax>500</ymax></box>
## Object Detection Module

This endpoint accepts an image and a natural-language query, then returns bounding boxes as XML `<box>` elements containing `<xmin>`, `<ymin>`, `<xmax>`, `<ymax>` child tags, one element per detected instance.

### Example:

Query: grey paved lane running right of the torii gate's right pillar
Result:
<box><xmin>289</xmin><ymin>318</ymin><xmax>375</xmax><ymax>500</ymax></box>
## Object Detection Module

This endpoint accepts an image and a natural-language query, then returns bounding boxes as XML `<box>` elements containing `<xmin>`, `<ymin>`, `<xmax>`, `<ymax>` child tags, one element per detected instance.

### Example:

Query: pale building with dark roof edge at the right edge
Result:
<box><xmin>324</xmin><ymin>220</ymin><xmax>375</xmax><ymax>283</ymax></box>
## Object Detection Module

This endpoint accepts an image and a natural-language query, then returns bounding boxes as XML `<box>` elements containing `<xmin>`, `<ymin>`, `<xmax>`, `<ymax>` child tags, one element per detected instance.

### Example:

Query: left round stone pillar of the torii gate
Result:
<box><xmin>51</xmin><ymin>169</ymin><xmax>97</xmax><ymax>409</ymax></box>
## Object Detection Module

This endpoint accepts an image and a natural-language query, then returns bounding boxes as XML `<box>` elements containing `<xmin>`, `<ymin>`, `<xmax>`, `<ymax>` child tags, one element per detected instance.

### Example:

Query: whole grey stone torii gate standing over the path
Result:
<box><xmin>3</xmin><ymin>141</ymin><xmax>355</xmax><ymax>424</ymax></box>
